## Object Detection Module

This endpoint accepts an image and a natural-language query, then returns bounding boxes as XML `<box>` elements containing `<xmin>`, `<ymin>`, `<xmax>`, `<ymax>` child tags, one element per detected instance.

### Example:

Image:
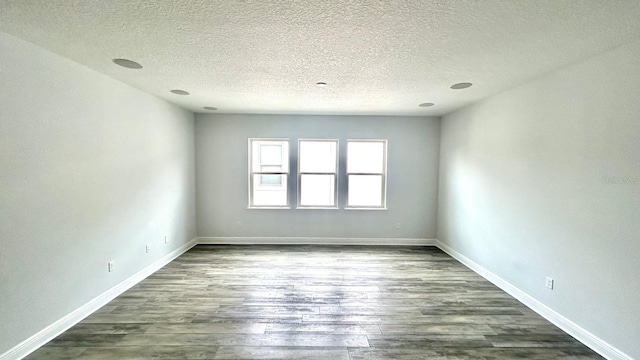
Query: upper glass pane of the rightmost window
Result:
<box><xmin>347</xmin><ymin>141</ymin><xmax>384</xmax><ymax>173</ymax></box>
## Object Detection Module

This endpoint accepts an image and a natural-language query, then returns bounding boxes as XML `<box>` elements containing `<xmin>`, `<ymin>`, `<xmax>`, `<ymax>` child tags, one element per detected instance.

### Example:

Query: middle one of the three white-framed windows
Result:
<box><xmin>298</xmin><ymin>140</ymin><xmax>338</xmax><ymax>208</ymax></box>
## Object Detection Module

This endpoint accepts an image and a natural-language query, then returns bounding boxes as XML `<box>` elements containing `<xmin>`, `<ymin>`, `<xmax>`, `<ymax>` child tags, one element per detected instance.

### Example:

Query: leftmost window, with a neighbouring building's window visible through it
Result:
<box><xmin>249</xmin><ymin>139</ymin><xmax>289</xmax><ymax>208</ymax></box>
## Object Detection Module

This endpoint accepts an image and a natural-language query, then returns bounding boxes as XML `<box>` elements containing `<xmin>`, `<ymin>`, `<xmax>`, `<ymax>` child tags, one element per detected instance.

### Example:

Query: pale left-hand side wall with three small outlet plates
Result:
<box><xmin>0</xmin><ymin>33</ymin><xmax>196</xmax><ymax>354</ymax></box>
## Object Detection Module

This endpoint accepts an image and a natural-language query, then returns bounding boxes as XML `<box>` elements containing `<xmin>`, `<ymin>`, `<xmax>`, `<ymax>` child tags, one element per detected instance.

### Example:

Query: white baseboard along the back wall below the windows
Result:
<box><xmin>198</xmin><ymin>237</ymin><xmax>436</xmax><ymax>246</ymax></box>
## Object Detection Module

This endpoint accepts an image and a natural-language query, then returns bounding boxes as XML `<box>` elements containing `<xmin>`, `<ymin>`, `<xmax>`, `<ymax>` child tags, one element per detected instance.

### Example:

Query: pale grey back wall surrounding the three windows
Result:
<box><xmin>196</xmin><ymin>114</ymin><xmax>440</xmax><ymax>239</ymax></box>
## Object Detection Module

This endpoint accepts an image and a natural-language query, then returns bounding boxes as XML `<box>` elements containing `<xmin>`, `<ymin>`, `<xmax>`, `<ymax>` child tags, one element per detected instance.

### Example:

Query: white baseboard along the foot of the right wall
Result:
<box><xmin>435</xmin><ymin>240</ymin><xmax>633</xmax><ymax>360</ymax></box>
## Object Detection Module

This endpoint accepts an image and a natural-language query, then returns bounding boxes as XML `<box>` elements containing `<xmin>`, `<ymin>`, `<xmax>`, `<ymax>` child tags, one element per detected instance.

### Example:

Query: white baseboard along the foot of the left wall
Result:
<box><xmin>0</xmin><ymin>238</ymin><xmax>198</xmax><ymax>360</ymax></box>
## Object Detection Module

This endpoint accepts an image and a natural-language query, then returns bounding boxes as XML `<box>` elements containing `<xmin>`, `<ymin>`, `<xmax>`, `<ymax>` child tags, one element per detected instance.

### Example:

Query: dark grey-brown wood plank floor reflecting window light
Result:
<box><xmin>27</xmin><ymin>245</ymin><xmax>601</xmax><ymax>360</ymax></box>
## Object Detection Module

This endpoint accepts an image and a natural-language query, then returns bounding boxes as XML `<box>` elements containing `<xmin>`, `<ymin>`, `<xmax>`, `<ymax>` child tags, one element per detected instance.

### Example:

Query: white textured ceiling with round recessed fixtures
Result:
<box><xmin>0</xmin><ymin>0</ymin><xmax>640</xmax><ymax>115</ymax></box>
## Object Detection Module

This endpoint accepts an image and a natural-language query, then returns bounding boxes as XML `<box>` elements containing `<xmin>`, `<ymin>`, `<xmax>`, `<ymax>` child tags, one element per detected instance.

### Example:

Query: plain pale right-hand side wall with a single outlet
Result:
<box><xmin>438</xmin><ymin>42</ymin><xmax>640</xmax><ymax>358</ymax></box>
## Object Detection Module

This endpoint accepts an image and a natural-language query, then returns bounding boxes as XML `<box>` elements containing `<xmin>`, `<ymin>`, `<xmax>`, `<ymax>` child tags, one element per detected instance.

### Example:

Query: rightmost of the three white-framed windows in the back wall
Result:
<box><xmin>347</xmin><ymin>140</ymin><xmax>387</xmax><ymax>208</ymax></box>
